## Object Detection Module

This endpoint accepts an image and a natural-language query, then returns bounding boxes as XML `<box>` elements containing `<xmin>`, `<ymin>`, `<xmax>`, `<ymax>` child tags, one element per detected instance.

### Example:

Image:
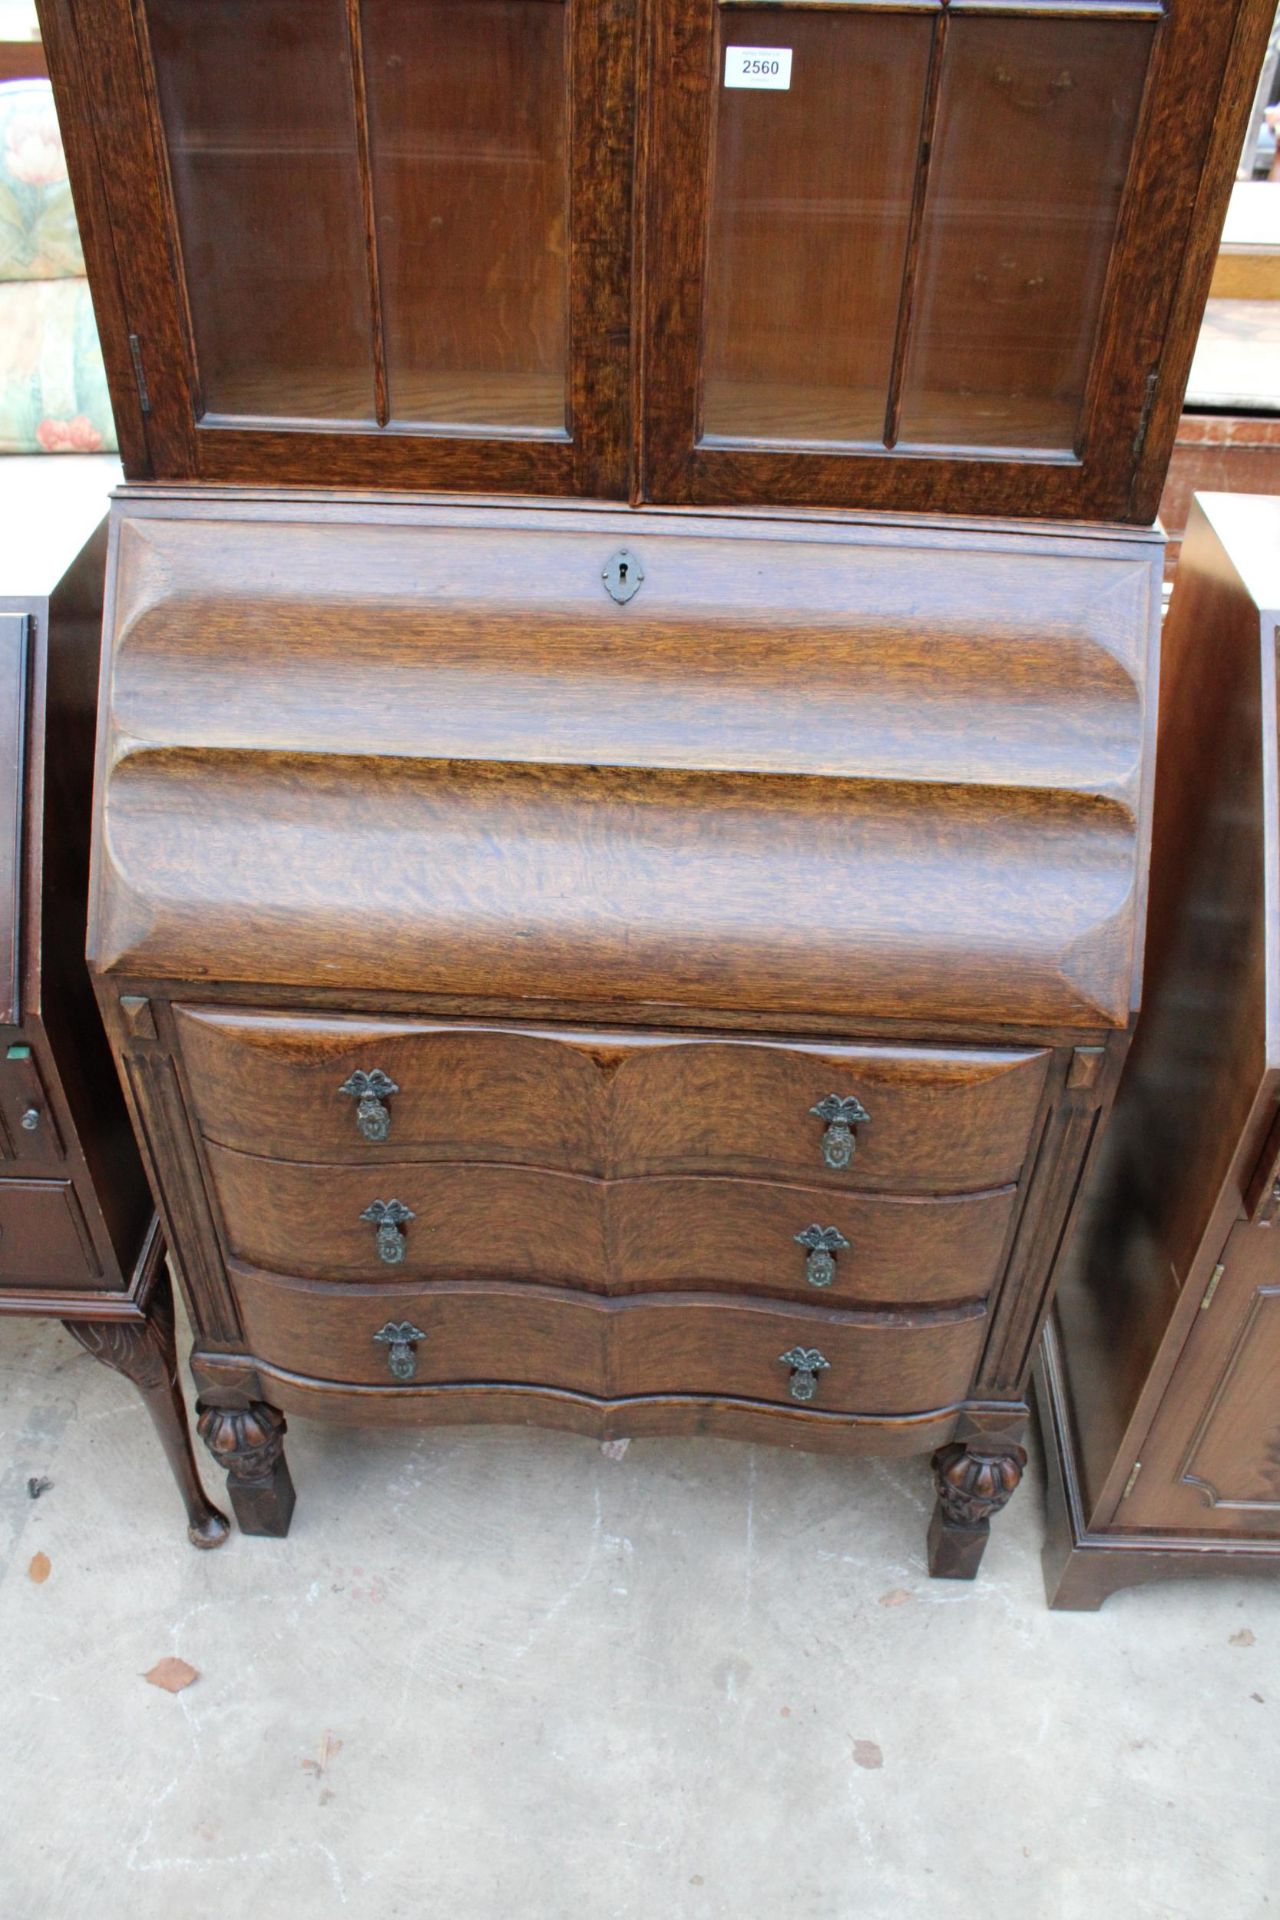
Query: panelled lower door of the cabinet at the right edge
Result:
<box><xmin>1117</xmin><ymin>1223</ymin><xmax>1280</xmax><ymax>1536</ymax></box>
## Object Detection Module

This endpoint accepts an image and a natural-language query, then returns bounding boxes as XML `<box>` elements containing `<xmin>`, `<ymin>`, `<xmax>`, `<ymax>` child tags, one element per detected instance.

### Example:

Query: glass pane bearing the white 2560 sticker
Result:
<box><xmin>702</xmin><ymin>8</ymin><xmax>933</xmax><ymax>445</ymax></box>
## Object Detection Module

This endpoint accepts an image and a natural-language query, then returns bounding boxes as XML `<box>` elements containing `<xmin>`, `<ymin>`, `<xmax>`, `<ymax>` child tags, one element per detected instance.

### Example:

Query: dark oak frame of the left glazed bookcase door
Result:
<box><xmin>38</xmin><ymin>0</ymin><xmax>635</xmax><ymax>497</ymax></box>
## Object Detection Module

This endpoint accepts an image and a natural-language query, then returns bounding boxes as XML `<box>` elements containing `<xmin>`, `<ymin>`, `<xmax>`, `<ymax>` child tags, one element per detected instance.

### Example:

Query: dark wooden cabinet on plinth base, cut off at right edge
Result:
<box><xmin>1040</xmin><ymin>493</ymin><xmax>1280</xmax><ymax>1609</ymax></box>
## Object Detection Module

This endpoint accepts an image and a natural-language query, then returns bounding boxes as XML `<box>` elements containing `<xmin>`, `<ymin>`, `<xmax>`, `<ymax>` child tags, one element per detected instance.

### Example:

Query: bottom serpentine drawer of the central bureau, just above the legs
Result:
<box><xmin>232</xmin><ymin>1271</ymin><xmax>986</xmax><ymax>1413</ymax></box>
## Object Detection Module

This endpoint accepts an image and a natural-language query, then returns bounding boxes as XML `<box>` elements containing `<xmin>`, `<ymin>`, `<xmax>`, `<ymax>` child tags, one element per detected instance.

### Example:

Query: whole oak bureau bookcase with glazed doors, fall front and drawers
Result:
<box><xmin>42</xmin><ymin>0</ymin><xmax>1270</xmax><ymax>1576</ymax></box>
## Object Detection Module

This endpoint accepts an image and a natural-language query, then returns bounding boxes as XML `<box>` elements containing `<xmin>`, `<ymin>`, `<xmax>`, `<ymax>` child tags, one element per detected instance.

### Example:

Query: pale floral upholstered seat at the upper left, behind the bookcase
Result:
<box><xmin>0</xmin><ymin>81</ymin><xmax>115</xmax><ymax>453</ymax></box>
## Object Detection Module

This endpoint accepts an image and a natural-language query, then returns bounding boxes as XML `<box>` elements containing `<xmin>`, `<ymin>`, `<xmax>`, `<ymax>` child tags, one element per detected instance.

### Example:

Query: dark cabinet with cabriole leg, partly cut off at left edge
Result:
<box><xmin>0</xmin><ymin>459</ymin><xmax>226</xmax><ymax>1548</ymax></box>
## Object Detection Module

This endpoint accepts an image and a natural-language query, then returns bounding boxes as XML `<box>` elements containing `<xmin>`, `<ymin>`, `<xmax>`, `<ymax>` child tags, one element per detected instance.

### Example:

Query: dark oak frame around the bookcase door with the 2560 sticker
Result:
<box><xmin>643</xmin><ymin>0</ymin><xmax>1272</xmax><ymax>524</ymax></box>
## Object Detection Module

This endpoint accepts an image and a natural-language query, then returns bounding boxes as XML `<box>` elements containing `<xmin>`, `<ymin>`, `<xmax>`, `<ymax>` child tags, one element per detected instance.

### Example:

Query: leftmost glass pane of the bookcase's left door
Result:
<box><xmin>148</xmin><ymin>0</ymin><xmax>374</xmax><ymax>420</ymax></box>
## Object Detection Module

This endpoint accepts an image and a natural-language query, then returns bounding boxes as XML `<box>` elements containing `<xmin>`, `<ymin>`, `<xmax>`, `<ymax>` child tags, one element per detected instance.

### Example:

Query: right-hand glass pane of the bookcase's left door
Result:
<box><xmin>363</xmin><ymin>0</ymin><xmax>568</xmax><ymax>430</ymax></box>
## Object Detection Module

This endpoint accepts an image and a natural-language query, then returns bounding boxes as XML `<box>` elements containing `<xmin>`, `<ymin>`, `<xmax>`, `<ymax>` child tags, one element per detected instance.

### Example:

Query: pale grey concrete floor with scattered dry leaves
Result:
<box><xmin>0</xmin><ymin>1321</ymin><xmax>1280</xmax><ymax>1920</ymax></box>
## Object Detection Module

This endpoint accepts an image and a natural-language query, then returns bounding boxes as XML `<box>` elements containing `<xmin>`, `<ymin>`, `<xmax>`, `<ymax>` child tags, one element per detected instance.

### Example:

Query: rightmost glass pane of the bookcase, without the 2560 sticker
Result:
<box><xmin>900</xmin><ymin>15</ymin><xmax>1153</xmax><ymax>451</ymax></box>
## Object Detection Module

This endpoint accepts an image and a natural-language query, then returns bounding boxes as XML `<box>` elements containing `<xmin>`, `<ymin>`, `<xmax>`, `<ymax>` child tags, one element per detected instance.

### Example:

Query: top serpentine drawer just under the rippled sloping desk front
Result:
<box><xmin>177</xmin><ymin>1008</ymin><xmax>1052</xmax><ymax>1192</ymax></box>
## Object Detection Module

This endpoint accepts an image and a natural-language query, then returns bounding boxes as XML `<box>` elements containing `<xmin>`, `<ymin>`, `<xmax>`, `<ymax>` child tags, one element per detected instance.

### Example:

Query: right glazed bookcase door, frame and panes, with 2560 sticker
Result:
<box><xmin>647</xmin><ymin>0</ymin><xmax>1261</xmax><ymax>518</ymax></box>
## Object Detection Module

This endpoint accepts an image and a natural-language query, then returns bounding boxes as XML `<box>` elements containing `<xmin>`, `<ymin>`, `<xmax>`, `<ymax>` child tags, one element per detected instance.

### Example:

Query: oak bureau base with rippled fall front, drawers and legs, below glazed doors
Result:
<box><xmin>90</xmin><ymin>486</ymin><xmax>1161</xmax><ymax>1576</ymax></box>
